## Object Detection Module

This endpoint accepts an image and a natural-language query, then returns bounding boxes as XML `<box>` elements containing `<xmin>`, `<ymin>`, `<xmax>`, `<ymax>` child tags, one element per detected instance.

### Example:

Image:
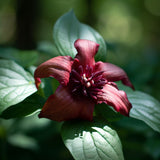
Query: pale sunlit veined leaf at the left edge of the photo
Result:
<box><xmin>0</xmin><ymin>60</ymin><xmax>37</xmax><ymax>113</ymax></box>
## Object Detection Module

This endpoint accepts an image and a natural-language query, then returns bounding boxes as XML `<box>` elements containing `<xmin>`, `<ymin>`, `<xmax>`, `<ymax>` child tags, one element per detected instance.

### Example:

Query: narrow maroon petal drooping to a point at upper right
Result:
<box><xmin>96</xmin><ymin>61</ymin><xmax>134</xmax><ymax>89</ymax></box>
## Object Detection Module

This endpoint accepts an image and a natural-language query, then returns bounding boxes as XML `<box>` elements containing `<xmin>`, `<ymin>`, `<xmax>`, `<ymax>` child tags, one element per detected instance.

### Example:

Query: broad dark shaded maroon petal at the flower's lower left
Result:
<box><xmin>39</xmin><ymin>86</ymin><xmax>94</xmax><ymax>121</ymax></box>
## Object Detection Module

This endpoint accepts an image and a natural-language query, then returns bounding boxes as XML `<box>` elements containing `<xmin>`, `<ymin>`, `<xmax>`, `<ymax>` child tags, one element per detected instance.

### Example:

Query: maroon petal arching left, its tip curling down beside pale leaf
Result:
<box><xmin>34</xmin><ymin>56</ymin><xmax>73</xmax><ymax>88</ymax></box>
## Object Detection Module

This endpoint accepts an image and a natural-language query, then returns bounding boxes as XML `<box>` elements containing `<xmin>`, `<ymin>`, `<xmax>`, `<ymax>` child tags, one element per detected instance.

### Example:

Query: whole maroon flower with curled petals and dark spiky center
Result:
<box><xmin>34</xmin><ymin>39</ymin><xmax>133</xmax><ymax>121</ymax></box>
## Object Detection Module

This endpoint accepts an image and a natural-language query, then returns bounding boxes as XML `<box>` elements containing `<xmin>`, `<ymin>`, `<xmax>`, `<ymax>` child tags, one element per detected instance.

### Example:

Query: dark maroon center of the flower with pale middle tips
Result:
<box><xmin>69</xmin><ymin>65</ymin><xmax>107</xmax><ymax>99</ymax></box>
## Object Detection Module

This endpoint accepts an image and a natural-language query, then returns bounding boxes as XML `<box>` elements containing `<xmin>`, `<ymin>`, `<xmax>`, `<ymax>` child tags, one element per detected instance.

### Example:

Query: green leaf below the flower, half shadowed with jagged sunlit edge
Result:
<box><xmin>62</xmin><ymin>121</ymin><xmax>124</xmax><ymax>160</ymax></box>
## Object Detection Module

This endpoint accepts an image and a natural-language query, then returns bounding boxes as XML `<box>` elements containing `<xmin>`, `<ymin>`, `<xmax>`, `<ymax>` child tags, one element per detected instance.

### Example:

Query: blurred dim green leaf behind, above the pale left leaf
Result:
<box><xmin>0</xmin><ymin>48</ymin><xmax>38</xmax><ymax>67</ymax></box>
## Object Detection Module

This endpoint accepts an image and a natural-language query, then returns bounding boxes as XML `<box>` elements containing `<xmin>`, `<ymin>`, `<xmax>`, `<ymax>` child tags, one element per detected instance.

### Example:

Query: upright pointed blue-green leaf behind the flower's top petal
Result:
<box><xmin>53</xmin><ymin>11</ymin><xmax>106</xmax><ymax>61</ymax></box>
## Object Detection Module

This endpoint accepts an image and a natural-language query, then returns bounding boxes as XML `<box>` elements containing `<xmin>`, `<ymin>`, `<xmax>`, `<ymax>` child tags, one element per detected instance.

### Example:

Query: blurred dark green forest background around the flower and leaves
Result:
<box><xmin>0</xmin><ymin>0</ymin><xmax>160</xmax><ymax>160</ymax></box>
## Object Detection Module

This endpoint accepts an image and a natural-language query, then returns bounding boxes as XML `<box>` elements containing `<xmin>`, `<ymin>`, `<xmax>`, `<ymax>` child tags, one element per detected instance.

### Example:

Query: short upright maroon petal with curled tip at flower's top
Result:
<box><xmin>74</xmin><ymin>39</ymin><xmax>99</xmax><ymax>67</ymax></box>
